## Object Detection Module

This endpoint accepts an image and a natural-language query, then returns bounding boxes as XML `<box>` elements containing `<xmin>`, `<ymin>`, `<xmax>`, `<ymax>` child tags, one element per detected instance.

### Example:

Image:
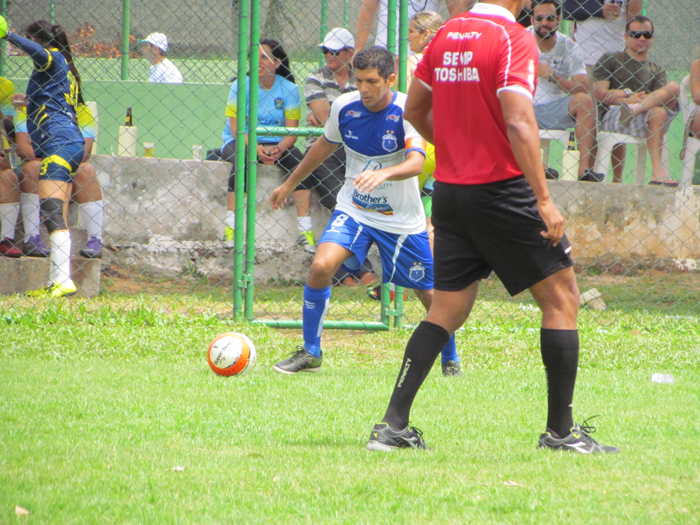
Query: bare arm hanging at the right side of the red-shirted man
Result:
<box><xmin>498</xmin><ymin>90</ymin><xmax>564</xmax><ymax>246</ymax></box>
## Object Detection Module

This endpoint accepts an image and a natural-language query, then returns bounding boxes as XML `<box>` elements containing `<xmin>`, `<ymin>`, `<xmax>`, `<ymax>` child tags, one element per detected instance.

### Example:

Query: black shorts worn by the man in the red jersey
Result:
<box><xmin>432</xmin><ymin>176</ymin><xmax>574</xmax><ymax>295</ymax></box>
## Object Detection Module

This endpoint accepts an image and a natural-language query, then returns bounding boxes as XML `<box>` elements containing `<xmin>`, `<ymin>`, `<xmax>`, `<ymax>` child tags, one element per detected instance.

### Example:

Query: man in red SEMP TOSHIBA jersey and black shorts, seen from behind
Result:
<box><xmin>367</xmin><ymin>0</ymin><xmax>619</xmax><ymax>453</ymax></box>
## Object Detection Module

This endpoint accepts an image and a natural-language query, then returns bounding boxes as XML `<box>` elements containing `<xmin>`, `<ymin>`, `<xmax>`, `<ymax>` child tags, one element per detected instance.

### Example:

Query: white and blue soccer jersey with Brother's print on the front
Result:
<box><xmin>323</xmin><ymin>91</ymin><xmax>425</xmax><ymax>234</ymax></box>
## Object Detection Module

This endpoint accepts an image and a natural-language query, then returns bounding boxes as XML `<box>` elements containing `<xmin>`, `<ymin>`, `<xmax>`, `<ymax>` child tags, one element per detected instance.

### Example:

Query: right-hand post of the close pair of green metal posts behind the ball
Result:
<box><xmin>243</xmin><ymin>0</ymin><xmax>260</xmax><ymax>320</ymax></box>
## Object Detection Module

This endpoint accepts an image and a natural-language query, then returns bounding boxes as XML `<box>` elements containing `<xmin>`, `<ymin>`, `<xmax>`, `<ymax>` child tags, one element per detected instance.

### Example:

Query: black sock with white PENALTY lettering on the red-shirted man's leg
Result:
<box><xmin>382</xmin><ymin>321</ymin><xmax>450</xmax><ymax>430</ymax></box>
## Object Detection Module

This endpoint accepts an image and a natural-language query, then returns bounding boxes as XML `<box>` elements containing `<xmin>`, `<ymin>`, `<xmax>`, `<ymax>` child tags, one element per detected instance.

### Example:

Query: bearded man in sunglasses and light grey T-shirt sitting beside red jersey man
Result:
<box><xmin>528</xmin><ymin>0</ymin><xmax>605</xmax><ymax>182</ymax></box>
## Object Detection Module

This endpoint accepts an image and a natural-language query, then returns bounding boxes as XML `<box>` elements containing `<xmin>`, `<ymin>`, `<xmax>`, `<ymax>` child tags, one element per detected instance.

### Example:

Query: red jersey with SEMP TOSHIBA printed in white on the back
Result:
<box><xmin>415</xmin><ymin>3</ymin><xmax>538</xmax><ymax>185</ymax></box>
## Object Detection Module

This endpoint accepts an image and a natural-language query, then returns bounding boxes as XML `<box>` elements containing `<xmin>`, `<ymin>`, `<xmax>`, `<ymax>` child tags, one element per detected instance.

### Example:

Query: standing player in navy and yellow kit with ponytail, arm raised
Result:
<box><xmin>4</xmin><ymin>20</ymin><xmax>85</xmax><ymax>297</ymax></box>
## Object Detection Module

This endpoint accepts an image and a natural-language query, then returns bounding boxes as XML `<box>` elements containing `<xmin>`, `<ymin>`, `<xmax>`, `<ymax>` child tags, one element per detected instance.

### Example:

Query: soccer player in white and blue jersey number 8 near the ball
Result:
<box><xmin>270</xmin><ymin>46</ymin><xmax>461</xmax><ymax>375</ymax></box>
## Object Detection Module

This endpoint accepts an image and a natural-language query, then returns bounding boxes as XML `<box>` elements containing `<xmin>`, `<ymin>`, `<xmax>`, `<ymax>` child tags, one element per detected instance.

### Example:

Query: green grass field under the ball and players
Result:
<box><xmin>0</xmin><ymin>298</ymin><xmax>700</xmax><ymax>524</ymax></box>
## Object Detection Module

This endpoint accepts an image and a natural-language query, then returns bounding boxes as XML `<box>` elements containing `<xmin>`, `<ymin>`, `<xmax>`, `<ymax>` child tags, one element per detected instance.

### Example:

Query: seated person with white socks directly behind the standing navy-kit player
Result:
<box><xmin>13</xmin><ymin>92</ymin><xmax>104</xmax><ymax>258</ymax></box>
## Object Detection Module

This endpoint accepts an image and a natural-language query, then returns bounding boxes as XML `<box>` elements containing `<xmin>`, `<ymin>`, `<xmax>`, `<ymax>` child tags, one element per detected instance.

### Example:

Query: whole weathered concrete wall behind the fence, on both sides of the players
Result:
<box><xmin>85</xmin><ymin>156</ymin><xmax>700</xmax><ymax>282</ymax></box>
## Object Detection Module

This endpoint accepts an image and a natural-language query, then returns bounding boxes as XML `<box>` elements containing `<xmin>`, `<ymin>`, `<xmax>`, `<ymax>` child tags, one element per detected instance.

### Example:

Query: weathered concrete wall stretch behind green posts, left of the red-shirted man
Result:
<box><xmin>92</xmin><ymin>155</ymin><xmax>330</xmax><ymax>281</ymax></box>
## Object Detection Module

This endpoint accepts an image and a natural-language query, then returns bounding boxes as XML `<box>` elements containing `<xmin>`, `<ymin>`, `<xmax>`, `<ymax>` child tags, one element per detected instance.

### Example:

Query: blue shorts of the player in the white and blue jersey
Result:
<box><xmin>318</xmin><ymin>211</ymin><xmax>433</xmax><ymax>290</ymax></box>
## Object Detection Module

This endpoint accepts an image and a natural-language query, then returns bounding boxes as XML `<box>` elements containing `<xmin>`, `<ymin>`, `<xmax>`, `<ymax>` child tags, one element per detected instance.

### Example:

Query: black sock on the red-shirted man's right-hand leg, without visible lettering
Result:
<box><xmin>540</xmin><ymin>328</ymin><xmax>578</xmax><ymax>438</ymax></box>
